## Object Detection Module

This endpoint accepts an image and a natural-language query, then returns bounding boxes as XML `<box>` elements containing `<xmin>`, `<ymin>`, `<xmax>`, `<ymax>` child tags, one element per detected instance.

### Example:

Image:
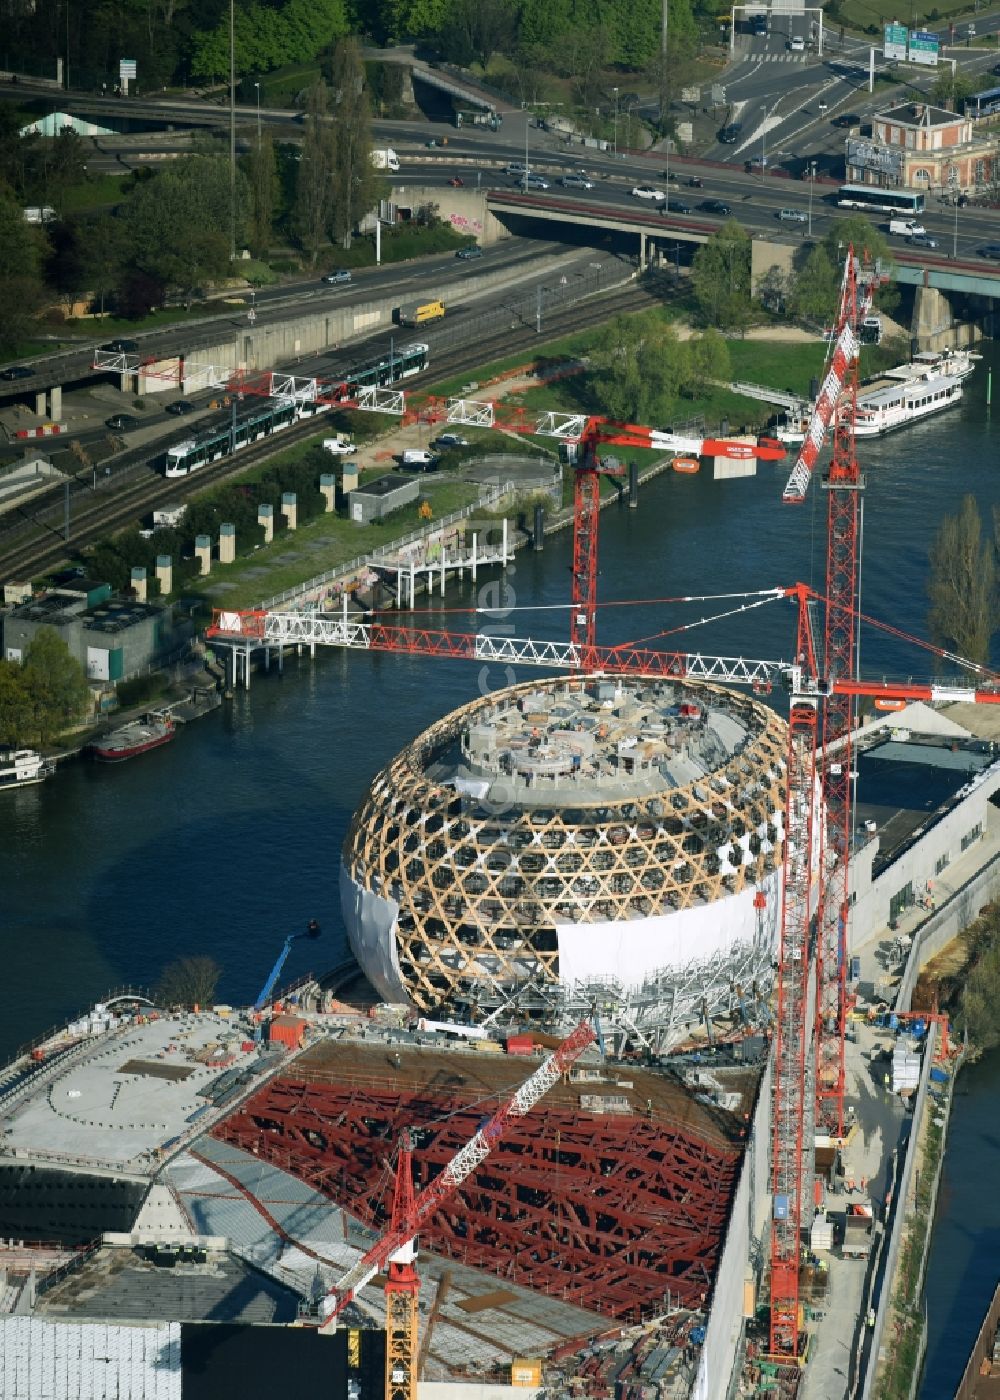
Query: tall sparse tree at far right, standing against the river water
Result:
<box><xmin>927</xmin><ymin>496</ymin><xmax>997</xmax><ymax>665</ymax></box>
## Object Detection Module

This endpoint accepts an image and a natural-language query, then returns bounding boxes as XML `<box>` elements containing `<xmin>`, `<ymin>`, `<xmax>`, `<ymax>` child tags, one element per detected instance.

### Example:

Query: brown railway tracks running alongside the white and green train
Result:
<box><xmin>0</xmin><ymin>275</ymin><xmax>657</xmax><ymax>580</ymax></box>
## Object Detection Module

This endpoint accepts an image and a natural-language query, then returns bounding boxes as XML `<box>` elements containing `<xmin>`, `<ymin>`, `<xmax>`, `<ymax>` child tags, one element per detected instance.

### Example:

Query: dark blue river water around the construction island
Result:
<box><xmin>0</xmin><ymin>347</ymin><xmax>1000</xmax><ymax>1377</ymax></box>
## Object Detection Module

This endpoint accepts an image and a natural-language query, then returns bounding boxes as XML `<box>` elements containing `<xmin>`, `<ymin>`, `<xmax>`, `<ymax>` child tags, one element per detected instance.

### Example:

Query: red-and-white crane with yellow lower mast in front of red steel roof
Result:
<box><xmin>313</xmin><ymin>1021</ymin><xmax>597</xmax><ymax>1400</ymax></box>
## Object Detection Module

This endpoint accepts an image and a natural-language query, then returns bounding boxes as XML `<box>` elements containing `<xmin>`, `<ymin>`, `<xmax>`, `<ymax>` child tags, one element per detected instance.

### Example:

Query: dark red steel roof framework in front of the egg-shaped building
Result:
<box><xmin>208</xmin><ymin>1078</ymin><xmax>742</xmax><ymax>1320</ymax></box>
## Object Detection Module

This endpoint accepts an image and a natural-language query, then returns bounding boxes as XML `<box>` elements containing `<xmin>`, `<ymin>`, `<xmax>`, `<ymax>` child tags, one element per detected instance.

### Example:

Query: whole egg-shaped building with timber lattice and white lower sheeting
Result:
<box><xmin>342</xmin><ymin>678</ymin><xmax>786</xmax><ymax>1049</ymax></box>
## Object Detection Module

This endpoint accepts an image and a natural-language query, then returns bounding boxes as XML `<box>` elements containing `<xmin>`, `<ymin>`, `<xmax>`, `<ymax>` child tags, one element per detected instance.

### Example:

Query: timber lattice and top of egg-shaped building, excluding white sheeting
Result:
<box><xmin>343</xmin><ymin>678</ymin><xmax>786</xmax><ymax>1012</ymax></box>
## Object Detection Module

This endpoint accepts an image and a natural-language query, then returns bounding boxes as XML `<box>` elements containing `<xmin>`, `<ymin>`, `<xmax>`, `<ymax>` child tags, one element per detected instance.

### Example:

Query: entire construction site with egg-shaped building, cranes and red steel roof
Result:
<box><xmin>0</xmin><ymin>251</ymin><xmax>1000</xmax><ymax>1400</ymax></box>
